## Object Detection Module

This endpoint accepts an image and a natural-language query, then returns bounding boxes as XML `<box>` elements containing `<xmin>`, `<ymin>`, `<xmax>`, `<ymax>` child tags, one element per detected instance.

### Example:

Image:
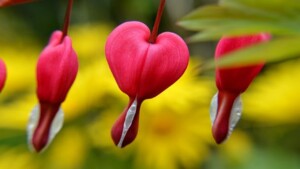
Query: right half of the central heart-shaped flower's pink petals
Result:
<box><xmin>138</xmin><ymin>32</ymin><xmax>189</xmax><ymax>98</ymax></box>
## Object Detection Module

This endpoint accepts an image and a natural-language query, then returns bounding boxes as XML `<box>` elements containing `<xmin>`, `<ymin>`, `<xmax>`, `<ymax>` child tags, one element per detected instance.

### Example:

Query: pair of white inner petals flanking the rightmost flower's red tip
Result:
<box><xmin>210</xmin><ymin>93</ymin><xmax>242</xmax><ymax>137</ymax></box>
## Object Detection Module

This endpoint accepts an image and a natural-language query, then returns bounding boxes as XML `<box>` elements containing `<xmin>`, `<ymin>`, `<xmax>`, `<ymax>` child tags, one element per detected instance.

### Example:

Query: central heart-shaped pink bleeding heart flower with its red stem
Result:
<box><xmin>105</xmin><ymin>0</ymin><xmax>189</xmax><ymax>147</ymax></box>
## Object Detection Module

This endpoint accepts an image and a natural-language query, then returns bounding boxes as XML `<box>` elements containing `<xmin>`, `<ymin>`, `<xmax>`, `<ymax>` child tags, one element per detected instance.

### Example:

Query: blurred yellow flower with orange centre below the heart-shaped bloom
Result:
<box><xmin>90</xmin><ymin>61</ymin><xmax>217</xmax><ymax>169</ymax></box>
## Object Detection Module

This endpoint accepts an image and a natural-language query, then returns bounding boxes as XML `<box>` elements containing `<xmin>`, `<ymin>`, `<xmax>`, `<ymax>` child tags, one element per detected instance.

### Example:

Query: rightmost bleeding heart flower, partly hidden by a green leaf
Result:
<box><xmin>210</xmin><ymin>33</ymin><xmax>271</xmax><ymax>144</ymax></box>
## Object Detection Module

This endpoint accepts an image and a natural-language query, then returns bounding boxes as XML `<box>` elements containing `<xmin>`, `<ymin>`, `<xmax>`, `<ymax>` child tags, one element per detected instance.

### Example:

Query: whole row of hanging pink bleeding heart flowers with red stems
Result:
<box><xmin>0</xmin><ymin>0</ymin><xmax>270</xmax><ymax>152</ymax></box>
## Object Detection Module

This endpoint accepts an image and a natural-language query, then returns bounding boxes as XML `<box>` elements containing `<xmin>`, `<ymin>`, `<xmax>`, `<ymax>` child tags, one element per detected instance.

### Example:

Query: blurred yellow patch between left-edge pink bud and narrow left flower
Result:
<box><xmin>0</xmin><ymin>45</ymin><xmax>37</xmax><ymax>129</ymax></box>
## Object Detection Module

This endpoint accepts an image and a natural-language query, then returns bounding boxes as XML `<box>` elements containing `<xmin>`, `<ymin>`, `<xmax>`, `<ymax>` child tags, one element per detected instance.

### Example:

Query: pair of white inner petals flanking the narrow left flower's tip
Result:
<box><xmin>27</xmin><ymin>105</ymin><xmax>64</xmax><ymax>151</ymax></box>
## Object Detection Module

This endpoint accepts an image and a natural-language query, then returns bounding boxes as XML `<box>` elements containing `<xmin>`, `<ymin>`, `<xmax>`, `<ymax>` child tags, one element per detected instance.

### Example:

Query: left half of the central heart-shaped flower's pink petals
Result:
<box><xmin>105</xmin><ymin>22</ymin><xmax>150</xmax><ymax>98</ymax></box>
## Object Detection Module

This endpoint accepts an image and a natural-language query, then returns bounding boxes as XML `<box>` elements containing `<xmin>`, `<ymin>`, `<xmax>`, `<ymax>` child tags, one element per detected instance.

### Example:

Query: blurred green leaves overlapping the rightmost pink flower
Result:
<box><xmin>178</xmin><ymin>0</ymin><xmax>300</xmax><ymax>67</ymax></box>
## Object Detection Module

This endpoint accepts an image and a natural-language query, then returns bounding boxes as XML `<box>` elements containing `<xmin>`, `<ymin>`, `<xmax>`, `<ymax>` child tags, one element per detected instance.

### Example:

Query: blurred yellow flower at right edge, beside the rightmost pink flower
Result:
<box><xmin>242</xmin><ymin>60</ymin><xmax>300</xmax><ymax>124</ymax></box>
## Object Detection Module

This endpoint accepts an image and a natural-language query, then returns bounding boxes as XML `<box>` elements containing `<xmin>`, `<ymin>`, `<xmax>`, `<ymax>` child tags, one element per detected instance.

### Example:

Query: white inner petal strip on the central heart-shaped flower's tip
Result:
<box><xmin>118</xmin><ymin>99</ymin><xmax>137</xmax><ymax>147</ymax></box>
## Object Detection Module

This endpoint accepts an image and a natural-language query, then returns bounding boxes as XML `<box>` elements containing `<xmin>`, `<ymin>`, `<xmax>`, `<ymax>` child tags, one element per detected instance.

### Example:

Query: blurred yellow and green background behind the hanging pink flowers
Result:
<box><xmin>0</xmin><ymin>0</ymin><xmax>300</xmax><ymax>169</ymax></box>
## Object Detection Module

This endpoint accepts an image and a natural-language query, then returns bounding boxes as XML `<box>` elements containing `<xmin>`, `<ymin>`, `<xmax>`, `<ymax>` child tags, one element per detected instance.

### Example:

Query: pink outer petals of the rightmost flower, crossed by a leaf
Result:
<box><xmin>215</xmin><ymin>33</ymin><xmax>271</xmax><ymax>93</ymax></box>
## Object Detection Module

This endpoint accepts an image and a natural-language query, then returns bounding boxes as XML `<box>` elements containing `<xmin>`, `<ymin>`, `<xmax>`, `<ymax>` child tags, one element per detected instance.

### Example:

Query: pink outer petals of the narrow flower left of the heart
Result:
<box><xmin>37</xmin><ymin>31</ymin><xmax>78</xmax><ymax>103</ymax></box>
